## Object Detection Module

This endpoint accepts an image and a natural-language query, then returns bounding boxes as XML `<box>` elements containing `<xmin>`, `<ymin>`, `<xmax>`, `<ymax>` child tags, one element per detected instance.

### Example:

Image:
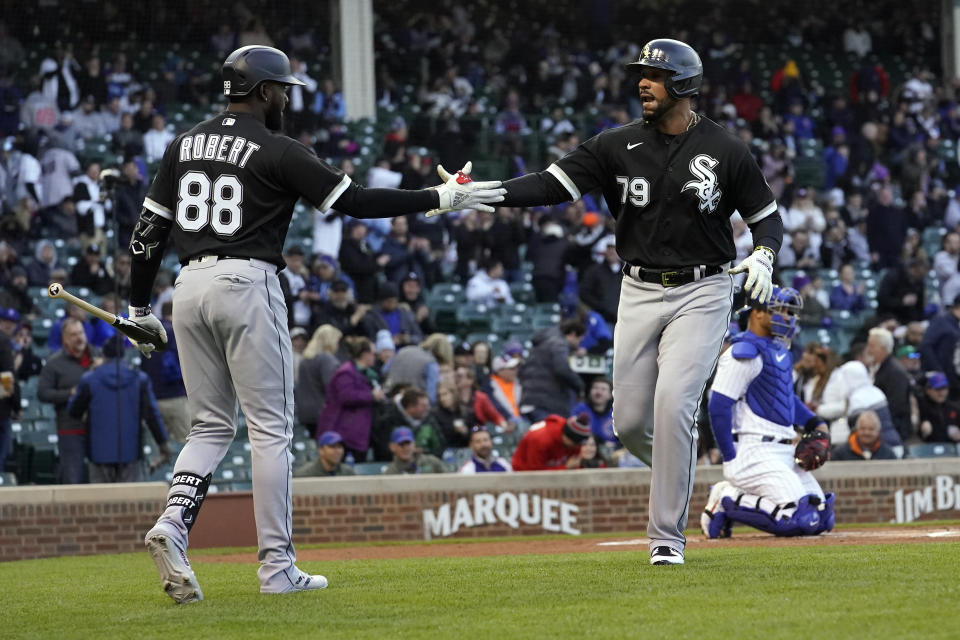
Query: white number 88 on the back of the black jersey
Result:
<box><xmin>177</xmin><ymin>171</ymin><xmax>243</xmax><ymax>236</ymax></box>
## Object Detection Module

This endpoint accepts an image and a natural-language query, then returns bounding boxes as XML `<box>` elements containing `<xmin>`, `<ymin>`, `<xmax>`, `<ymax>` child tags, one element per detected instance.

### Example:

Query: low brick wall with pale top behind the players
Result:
<box><xmin>0</xmin><ymin>459</ymin><xmax>960</xmax><ymax>560</ymax></box>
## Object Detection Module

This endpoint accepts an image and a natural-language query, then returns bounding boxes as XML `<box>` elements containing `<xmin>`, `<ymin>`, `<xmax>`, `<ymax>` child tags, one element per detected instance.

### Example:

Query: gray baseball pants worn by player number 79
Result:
<box><xmin>613</xmin><ymin>268</ymin><xmax>733</xmax><ymax>553</ymax></box>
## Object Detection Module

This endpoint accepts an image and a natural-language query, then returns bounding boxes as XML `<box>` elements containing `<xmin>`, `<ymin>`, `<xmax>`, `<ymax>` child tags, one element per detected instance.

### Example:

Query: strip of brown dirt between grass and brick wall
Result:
<box><xmin>199</xmin><ymin>526</ymin><xmax>960</xmax><ymax>562</ymax></box>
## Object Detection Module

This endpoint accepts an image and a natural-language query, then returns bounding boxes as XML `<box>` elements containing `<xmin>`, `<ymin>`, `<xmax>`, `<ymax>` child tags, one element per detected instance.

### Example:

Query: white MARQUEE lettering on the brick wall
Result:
<box><xmin>423</xmin><ymin>492</ymin><xmax>580</xmax><ymax>540</ymax></box>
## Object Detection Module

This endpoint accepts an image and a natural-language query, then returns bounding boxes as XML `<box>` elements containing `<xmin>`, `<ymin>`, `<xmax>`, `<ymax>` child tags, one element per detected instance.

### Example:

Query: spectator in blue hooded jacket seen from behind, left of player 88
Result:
<box><xmin>67</xmin><ymin>336</ymin><xmax>173</xmax><ymax>482</ymax></box>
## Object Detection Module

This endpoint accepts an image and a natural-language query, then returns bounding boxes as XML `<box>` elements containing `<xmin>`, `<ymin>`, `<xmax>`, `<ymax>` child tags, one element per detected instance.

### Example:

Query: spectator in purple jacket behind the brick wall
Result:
<box><xmin>316</xmin><ymin>336</ymin><xmax>386</xmax><ymax>461</ymax></box>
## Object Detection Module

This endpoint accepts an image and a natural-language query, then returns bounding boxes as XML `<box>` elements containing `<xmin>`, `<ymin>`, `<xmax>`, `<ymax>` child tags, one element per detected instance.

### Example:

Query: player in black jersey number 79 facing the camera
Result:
<box><xmin>484</xmin><ymin>39</ymin><xmax>783</xmax><ymax>564</ymax></box>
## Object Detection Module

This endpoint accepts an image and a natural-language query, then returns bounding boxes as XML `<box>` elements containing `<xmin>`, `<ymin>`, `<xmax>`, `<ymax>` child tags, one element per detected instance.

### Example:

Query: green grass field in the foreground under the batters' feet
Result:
<box><xmin>0</xmin><ymin>543</ymin><xmax>960</xmax><ymax>640</ymax></box>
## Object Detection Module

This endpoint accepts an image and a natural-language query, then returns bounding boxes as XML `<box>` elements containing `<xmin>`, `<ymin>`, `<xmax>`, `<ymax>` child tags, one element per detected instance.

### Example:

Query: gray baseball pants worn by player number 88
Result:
<box><xmin>158</xmin><ymin>257</ymin><xmax>298</xmax><ymax>591</ymax></box>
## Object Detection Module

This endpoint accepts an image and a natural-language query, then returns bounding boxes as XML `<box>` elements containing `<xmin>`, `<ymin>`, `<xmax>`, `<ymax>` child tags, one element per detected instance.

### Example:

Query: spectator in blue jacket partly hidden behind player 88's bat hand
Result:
<box><xmin>140</xmin><ymin>300</ymin><xmax>190</xmax><ymax>442</ymax></box>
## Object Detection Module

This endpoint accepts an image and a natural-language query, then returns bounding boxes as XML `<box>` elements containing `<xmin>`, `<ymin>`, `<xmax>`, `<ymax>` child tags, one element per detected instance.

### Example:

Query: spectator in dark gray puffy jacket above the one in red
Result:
<box><xmin>520</xmin><ymin>320</ymin><xmax>586</xmax><ymax>422</ymax></box>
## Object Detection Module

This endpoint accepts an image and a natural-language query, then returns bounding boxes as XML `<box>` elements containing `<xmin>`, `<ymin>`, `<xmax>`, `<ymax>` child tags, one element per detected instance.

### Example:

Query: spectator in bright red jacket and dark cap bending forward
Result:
<box><xmin>513</xmin><ymin>413</ymin><xmax>590</xmax><ymax>471</ymax></box>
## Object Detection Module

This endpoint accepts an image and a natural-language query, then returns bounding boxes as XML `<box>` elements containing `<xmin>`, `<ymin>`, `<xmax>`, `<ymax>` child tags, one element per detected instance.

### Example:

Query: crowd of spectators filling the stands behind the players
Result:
<box><xmin>0</xmin><ymin>0</ymin><xmax>960</xmax><ymax>474</ymax></box>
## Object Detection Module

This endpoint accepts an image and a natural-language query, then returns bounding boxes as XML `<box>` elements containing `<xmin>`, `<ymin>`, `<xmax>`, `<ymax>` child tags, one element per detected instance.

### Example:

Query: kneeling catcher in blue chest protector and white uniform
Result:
<box><xmin>700</xmin><ymin>287</ymin><xmax>834</xmax><ymax>538</ymax></box>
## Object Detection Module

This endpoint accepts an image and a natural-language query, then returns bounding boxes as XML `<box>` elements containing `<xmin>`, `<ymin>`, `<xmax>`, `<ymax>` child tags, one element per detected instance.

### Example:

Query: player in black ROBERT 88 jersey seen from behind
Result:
<box><xmin>130</xmin><ymin>46</ymin><xmax>504</xmax><ymax>603</ymax></box>
